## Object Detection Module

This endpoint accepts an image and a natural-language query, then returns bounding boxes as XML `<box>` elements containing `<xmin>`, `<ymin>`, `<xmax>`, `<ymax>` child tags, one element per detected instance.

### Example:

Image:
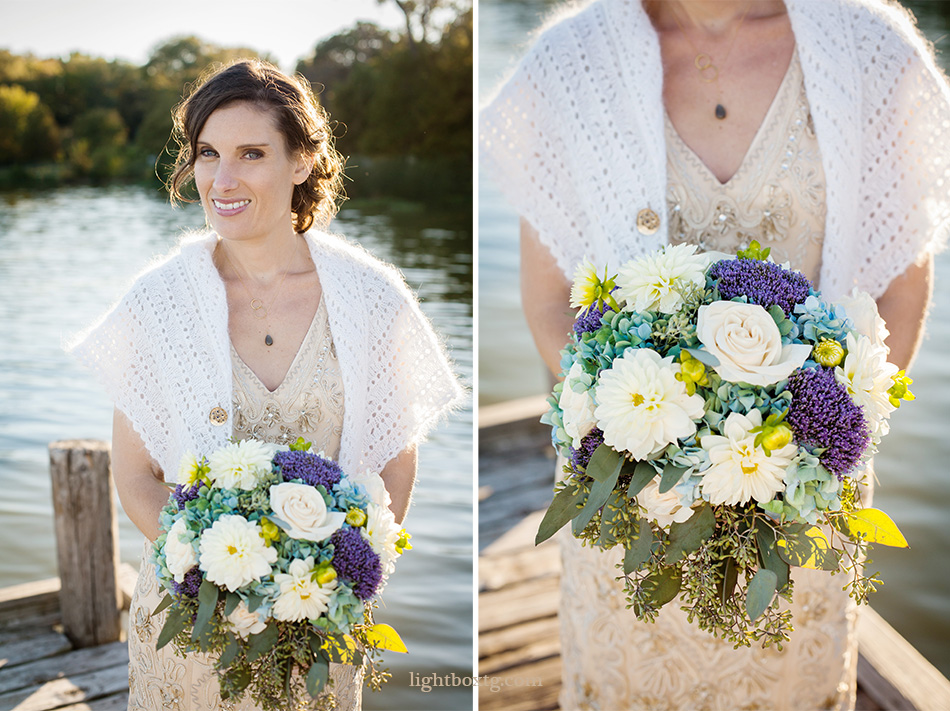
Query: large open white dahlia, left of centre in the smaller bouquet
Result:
<box><xmin>198</xmin><ymin>514</ymin><xmax>277</xmax><ymax>592</ymax></box>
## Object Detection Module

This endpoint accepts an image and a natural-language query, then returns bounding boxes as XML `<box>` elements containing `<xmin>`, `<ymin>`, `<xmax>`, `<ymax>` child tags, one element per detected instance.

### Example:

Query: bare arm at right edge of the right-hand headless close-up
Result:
<box><xmin>877</xmin><ymin>255</ymin><xmax>934</xmax><ymax>370</ymax></box>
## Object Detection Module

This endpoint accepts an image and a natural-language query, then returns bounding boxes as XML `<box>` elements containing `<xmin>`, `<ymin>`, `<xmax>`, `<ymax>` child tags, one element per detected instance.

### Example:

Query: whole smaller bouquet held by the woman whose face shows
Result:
<box><xmin>153</xmin><ymin>439</ymin><xmax>412</xmax><ymax>709</ymax></box>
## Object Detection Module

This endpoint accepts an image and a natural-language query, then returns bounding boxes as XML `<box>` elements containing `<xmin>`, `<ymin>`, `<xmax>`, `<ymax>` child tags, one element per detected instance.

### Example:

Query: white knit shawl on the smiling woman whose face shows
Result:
<box><xmin>69</xmin><ymin>232</ymin><xmax>462</xmax><ymax>480</ymax></box>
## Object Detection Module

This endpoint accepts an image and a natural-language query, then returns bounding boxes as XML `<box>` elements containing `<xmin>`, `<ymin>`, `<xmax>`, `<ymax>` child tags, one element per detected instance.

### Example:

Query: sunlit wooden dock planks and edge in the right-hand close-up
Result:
<box><xmin>478</xmin><ymin>397</ymin><xmax>950</xmax><ymax>711</ymax></box>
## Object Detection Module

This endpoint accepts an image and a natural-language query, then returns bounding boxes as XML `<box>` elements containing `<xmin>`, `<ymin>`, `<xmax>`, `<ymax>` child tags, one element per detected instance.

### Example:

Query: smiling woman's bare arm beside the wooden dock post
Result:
<box><xmin>112</xmin><ymin>409</ymin><xmax>169</xmax><ymax>541</ymax></box>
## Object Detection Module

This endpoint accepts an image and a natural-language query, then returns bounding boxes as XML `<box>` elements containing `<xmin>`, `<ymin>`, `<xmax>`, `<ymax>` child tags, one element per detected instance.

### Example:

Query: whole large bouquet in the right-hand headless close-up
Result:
<box><xmin>536</xmin><ymin>242</ymin><xmax>914</xmax><ymax>647</ymax></box>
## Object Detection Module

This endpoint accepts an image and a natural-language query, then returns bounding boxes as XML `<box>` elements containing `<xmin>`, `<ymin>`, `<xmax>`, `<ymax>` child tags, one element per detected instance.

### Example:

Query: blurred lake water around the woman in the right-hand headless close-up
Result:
<box><xmin>478</xmin><ymin>0</ymin><xmax>950</xmax><ymax>676</ymax></box>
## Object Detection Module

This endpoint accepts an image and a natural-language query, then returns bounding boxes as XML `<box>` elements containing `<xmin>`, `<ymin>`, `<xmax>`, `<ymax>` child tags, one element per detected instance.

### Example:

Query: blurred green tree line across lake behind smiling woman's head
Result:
<box><xmin>0</xmin><ymin>0</ymin><xmax>473</xmax><ymax>203</ymax></box>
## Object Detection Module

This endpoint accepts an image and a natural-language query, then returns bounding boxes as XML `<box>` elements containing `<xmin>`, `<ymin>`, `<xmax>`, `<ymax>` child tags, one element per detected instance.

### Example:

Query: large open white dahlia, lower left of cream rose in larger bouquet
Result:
<box><xmin>594</xmin><ymin>348</ymin><xmax>704</xmax><ymax>459</ymax></box>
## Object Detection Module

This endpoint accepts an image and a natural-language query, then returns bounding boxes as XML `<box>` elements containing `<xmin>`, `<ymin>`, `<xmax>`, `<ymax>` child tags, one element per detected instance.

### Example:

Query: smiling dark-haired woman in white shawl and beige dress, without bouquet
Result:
<box><xmin>73</xmin><ymin>60</ymin><xmax>460</xmax><ymax>711</ymax></box>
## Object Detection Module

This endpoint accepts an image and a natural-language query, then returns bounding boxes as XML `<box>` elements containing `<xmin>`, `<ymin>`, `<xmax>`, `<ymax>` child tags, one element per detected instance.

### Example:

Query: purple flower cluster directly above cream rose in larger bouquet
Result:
<box><xmin>709</xmin><ymin>258</ymin><xmax>811</xmax><ymax>316</ymax></box>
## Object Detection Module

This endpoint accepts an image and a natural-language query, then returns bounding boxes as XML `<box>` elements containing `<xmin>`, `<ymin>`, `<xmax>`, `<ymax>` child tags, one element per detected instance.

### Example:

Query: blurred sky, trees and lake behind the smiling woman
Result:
<box><xmin>0</xmin><ymin>0</ymin><xmax>473</xmax><ymax>710</ymax></box>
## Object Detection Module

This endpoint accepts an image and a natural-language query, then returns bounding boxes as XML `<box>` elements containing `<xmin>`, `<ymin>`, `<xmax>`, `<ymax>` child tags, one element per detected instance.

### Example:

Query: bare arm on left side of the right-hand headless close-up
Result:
<box><xmin>521</xmin><ymin>219</ymin><xmax>574</xmax><ymax>377</ymax></box>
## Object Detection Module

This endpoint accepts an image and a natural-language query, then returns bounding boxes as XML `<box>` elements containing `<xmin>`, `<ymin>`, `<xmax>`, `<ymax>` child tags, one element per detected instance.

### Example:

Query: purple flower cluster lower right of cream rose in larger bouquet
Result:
<box><xmin>787</xmin><ymin>368</ymin><xmax>870</xmax><ymax>479</ymax></box>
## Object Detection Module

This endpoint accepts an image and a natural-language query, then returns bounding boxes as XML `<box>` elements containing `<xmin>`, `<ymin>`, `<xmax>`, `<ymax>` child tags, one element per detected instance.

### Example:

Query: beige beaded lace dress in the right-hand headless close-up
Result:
<box><xmin>559</xmin><ymin>53</ymin><xmax>857</xmax><ymax>711</ymax></box>
